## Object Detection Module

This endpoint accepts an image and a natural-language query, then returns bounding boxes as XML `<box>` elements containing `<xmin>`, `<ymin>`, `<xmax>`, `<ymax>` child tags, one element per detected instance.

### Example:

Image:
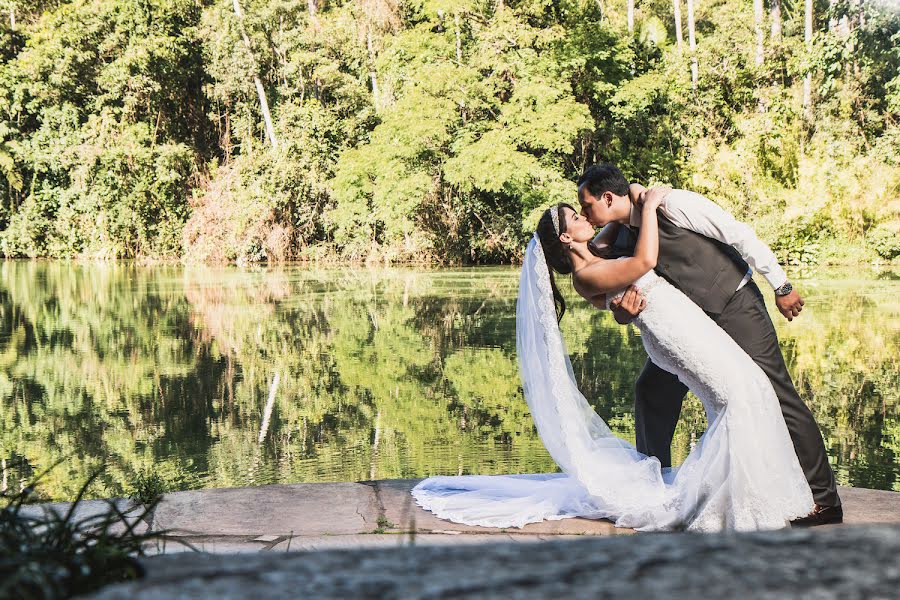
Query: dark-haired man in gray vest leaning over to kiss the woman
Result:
<box><xmin>578</xmin><ymin>164</ymin><xmax>843</xmax><ymax>526</ymax></box>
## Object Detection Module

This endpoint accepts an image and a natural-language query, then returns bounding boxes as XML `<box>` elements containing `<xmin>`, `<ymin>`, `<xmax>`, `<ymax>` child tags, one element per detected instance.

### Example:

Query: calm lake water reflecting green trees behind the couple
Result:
<box><xmin>0</xmin><ymin>261</ymin><xmax>900</xmax><ymax>500</ymax></box>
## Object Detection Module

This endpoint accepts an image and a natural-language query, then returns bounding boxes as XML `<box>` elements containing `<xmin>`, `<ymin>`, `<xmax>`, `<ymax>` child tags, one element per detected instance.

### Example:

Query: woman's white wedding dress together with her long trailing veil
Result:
<box><xmin>412</xmin><ymin>237</ymin><xmax>813</xmax><ymax>531</ymax></box>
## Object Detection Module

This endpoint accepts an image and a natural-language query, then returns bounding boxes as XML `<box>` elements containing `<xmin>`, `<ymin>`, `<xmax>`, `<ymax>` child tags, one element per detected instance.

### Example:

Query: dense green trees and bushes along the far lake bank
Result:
<box><xmin>0</xmin><ymin>0</ymin><xmax>900</xmax><ymax>263</ymax></box>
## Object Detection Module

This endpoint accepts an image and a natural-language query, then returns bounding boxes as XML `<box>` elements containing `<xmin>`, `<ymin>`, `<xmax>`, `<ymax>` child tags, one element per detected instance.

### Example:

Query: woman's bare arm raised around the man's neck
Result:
<box><xmin>575</xmin><ymin>194</ymin><xmax>661</xmax><ymax>296</ymax></box>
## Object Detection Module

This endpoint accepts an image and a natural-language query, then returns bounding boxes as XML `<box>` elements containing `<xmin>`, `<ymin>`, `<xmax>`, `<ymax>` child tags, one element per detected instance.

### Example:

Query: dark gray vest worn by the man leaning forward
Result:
<box><xmin>615</xmin><ymin>213</ymin><xmax>750</xmax><ymax>314</ymax></box>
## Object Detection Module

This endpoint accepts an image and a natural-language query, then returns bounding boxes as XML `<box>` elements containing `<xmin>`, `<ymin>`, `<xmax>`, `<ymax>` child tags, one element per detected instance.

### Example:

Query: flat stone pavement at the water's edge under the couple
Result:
<box><xmin>21</xmin><ymin>479</ymin><xmax>900</xmax><ymax>554</ymax></box>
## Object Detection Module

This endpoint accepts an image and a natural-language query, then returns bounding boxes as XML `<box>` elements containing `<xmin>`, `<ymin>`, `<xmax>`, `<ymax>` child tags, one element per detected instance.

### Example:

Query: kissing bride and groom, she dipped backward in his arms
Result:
<box><xmin>412</xmin><ymin>164</ymin><xmax>843</xmax><ymax>531</ymax></box>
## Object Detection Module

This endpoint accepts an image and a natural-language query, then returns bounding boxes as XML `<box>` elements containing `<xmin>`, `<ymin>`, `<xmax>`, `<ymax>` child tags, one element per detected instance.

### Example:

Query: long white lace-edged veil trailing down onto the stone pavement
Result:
<box><xmin>412</xmin><ymin>235</ymin><xmax>671</xmax><ymax>527</ymax></box>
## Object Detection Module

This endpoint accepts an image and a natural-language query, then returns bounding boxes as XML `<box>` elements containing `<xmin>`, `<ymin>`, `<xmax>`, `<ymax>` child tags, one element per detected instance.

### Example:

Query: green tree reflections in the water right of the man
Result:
<box><xmin>776</xmin><ymin>282</ymin><xmax>900</xmax><ymax>490</ymax></box>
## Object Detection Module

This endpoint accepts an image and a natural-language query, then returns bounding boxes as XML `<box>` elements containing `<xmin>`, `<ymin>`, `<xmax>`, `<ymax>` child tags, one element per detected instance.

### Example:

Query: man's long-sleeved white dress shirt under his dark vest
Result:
<box><xmin>629</xmin><ymin>190</ymin><xmax>787</xmax><ymax>290</ymax></box>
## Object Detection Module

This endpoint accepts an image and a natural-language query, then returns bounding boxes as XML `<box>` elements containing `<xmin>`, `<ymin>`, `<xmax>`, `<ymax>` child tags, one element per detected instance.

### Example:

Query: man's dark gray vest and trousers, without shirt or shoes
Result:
<box><xmin>620</xmin><ymin>217</ymin><xmax>841</xmax><ymax>506</ymax></box>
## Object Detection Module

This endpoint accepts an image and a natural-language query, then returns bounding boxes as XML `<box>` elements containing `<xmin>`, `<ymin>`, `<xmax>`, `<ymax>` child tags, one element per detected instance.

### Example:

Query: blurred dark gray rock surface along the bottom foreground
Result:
<box><xmin>86</xmin><ymin>525</ymin><xmax>900</xmax><ymax>600</ymax></box>
